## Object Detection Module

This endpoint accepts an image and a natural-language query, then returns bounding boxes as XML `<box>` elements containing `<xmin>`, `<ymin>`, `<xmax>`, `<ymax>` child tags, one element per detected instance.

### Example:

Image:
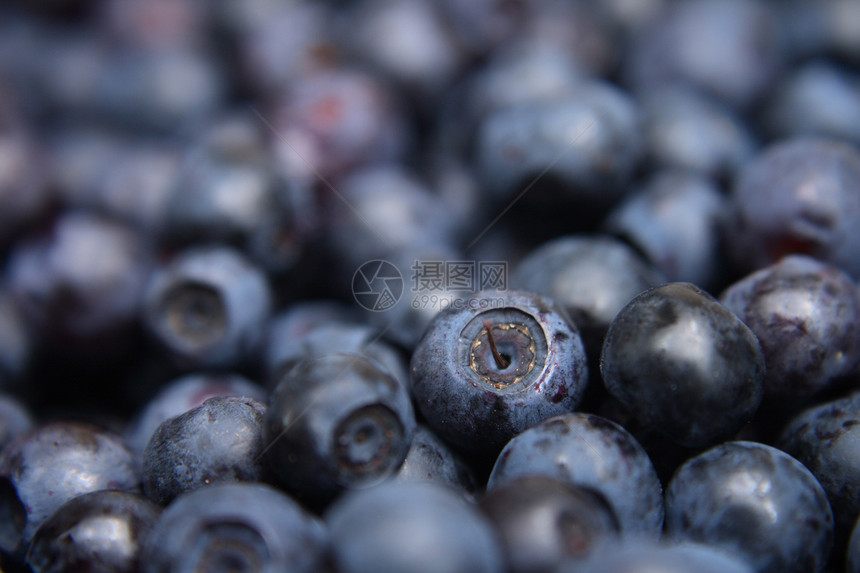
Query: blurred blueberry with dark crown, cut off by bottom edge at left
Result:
<box><xmin>141</xmin><ymin>483</ymin><xmax>328</xmax><ymax>573</ymax></box>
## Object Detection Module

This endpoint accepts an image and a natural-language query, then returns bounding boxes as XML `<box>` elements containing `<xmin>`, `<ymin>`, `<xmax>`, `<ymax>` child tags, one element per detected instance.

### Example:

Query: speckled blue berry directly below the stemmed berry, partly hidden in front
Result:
<box><xmin>487</xmin><ymin>413</ymin><xmax>663</xmax><ymax>538</ymax></box>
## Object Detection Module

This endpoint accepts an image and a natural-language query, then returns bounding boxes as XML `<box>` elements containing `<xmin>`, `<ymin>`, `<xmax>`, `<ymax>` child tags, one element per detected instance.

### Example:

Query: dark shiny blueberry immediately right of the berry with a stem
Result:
<box><xmin>600</xmin><ymin>283</ymin><xmax>765</xmax><ymax>447</ymax></box>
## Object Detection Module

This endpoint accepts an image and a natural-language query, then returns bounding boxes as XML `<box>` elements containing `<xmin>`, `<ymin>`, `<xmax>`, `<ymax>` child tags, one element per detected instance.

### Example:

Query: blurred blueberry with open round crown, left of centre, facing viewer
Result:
<box><xmin>144</xmin><ymin>246</ymin><xmax>271</xmax><ymax>367</ymax></box>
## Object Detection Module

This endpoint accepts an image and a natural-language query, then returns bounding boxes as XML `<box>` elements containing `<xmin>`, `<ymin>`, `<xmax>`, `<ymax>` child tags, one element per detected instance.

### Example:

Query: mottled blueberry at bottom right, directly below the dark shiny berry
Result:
<box><xmin>666</xmin><ymin>442</ymin><xmax>833</xmax><ymax>573</ymax></box>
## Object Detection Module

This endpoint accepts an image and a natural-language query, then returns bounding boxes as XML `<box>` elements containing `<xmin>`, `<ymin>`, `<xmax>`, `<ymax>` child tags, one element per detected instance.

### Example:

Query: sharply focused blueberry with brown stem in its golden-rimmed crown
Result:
<box><xmin>411</xmin><ymin>291</ymin><xmax>588</xmax><ymax>456</ymax></box>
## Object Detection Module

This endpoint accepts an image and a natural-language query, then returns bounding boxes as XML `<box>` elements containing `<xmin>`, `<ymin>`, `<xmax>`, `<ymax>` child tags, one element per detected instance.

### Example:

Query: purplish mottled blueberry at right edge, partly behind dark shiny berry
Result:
<box><xmin>720</xmin><ymin>255</ymin><xmax>860</xmax><ymax>405</ymax></box>
